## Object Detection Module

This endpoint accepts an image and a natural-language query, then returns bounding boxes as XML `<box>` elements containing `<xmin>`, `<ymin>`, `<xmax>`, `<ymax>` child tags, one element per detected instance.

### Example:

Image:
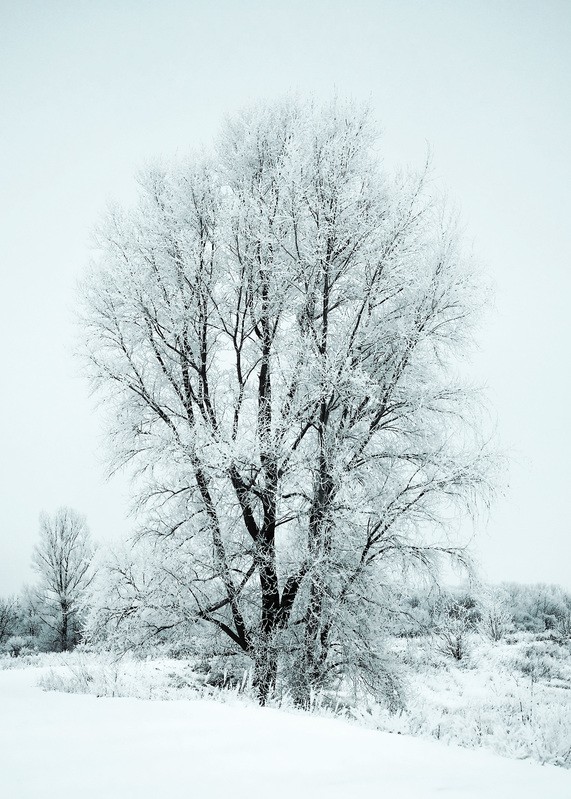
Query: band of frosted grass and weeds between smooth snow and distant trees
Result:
<box><xmin>0</xmin><ymin>587</ymin><xmax>571</xmax><ymax>784</ymax></box>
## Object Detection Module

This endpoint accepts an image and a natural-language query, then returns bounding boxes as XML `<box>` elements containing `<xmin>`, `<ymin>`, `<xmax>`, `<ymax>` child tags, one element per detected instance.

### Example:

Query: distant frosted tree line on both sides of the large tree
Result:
<box><xmin>0</xmin><ymin>552</ymin><xmax>571</xmax><ymax>670</ymax></box>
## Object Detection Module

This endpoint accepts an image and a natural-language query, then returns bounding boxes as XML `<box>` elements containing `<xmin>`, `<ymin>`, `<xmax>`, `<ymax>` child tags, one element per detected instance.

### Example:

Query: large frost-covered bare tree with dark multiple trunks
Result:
<box><xmin>84</xmin><ymin>101</ymin><xmax>494</xmax><ymax>703</ymax></box>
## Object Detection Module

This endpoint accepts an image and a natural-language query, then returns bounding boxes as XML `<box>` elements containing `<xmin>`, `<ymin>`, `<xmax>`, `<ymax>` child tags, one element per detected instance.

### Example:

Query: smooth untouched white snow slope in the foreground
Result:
<box><xmin>0</xmin><ymin>666</ymin><xmax>571</xmax><ymax>799</ymax></box>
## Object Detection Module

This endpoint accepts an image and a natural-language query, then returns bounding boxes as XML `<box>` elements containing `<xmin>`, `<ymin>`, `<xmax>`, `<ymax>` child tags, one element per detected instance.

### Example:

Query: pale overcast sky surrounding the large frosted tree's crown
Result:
<box><xmin>0</xmin><ymin>0</ymin><xmax>571</xmax><ymax>595</ymax></box>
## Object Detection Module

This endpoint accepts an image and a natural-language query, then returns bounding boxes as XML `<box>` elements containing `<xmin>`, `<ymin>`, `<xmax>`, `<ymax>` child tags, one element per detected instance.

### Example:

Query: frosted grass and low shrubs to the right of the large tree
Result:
<box><xmin>362</xmin><ymin>634</ymin><xmax>571</xmax><ymax>768</ymax></box>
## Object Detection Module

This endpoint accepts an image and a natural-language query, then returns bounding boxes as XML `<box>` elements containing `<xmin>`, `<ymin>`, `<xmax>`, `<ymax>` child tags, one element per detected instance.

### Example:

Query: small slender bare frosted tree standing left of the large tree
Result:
<box><xmin>32</xmin><ymin>508</ymin><xmax>94</xmax><ymax>651</ymax></box>
